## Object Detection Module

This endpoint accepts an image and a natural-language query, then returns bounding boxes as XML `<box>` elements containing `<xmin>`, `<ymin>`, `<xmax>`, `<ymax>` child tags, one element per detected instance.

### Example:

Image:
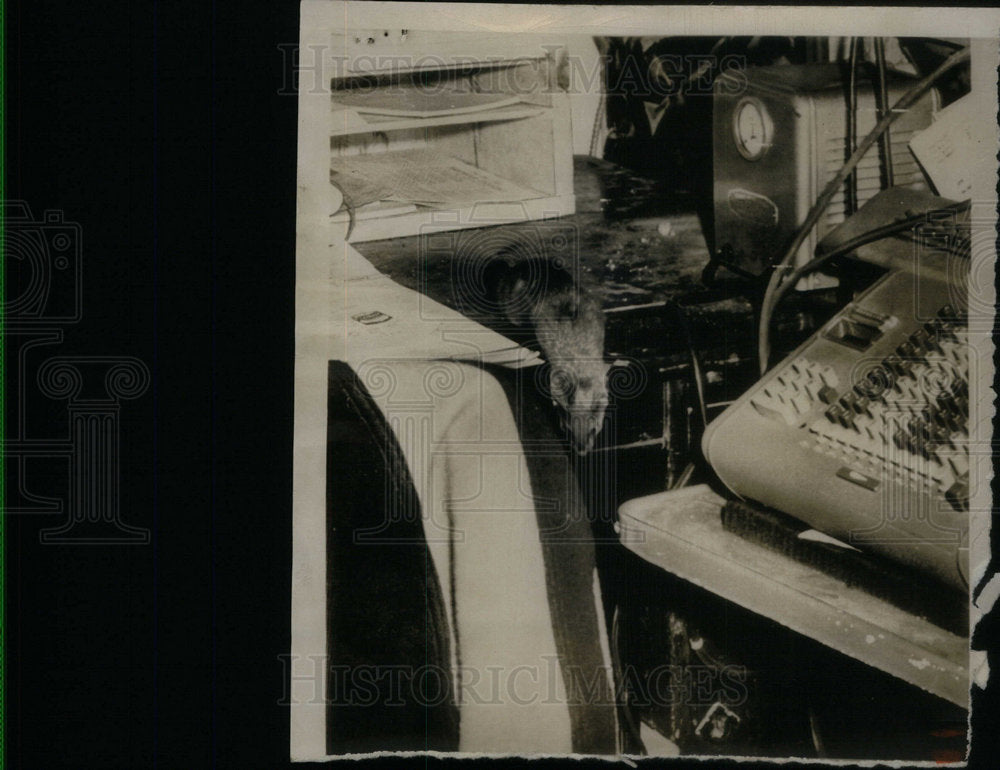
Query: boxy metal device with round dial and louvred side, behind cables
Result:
<box><xmin>713</xmin><ymin>64</ymin><xmax>937</xmax><ymax>288</ymax></box>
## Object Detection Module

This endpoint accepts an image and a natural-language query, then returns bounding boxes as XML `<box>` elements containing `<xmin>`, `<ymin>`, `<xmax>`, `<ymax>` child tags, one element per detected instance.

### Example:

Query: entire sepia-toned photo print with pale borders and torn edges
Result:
<box><xmin>285</xmin><ymin>0</ymin><xmax>1000</xmax><ymax>764</ymax></box>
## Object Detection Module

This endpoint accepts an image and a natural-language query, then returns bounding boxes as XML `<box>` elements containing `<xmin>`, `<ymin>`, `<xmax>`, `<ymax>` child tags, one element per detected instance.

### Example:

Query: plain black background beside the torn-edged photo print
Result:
<box><xmin>5</xmin><ymin>0</ymin><xmax>1000</xmax><ymax>768</ymax></box>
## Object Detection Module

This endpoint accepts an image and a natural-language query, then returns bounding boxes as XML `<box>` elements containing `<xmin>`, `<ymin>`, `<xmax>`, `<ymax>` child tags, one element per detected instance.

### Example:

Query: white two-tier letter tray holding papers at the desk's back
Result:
<box><xmin>321</xmin><ymin>14</ymin><xmax>574</xmax><ymax>242</ymax></box>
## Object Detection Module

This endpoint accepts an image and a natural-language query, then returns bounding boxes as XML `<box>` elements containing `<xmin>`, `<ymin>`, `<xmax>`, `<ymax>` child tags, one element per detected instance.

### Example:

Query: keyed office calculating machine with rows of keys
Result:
<box><xmin>702</xmin><ymin>238</ymin><xmax>970</xmax><ymax>588</ymax></box>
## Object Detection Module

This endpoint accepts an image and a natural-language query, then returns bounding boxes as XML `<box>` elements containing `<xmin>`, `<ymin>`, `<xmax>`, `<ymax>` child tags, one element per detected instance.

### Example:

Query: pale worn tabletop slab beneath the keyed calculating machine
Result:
<box><xmin>619</xmin><ymin>486</ymin><xmax>969</xmax><ymax>708</ymax></box>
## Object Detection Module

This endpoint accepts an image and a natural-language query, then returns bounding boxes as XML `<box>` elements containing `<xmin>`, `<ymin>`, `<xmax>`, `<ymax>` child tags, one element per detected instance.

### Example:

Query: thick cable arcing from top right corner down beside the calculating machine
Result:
<box><xmin>757</xmin><ymin>47</ymin><xmax>970</xmax><ymax>376</ymax></box>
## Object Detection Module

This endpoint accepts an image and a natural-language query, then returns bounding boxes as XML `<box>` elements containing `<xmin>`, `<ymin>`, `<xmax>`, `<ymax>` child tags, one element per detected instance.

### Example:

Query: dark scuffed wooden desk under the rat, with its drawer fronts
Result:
<box><xmin>356</xmin><ymin>156</ymin><xmax>822</xmax><ymax>495</ymax></box>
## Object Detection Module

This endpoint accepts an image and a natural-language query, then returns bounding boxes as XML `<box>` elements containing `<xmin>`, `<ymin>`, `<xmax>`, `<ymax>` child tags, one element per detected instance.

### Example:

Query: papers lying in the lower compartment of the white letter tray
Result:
<box><xmin>330</xmin><ymin>150</ymin><xmax>544</xmax><ymax>207</ymax></box>
